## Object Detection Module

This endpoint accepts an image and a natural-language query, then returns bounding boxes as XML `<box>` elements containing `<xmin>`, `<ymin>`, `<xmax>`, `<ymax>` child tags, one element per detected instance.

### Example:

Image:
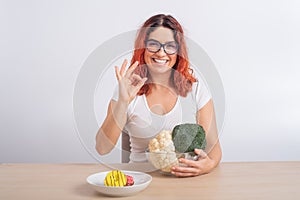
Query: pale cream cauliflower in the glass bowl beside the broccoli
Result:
<box><xmin>148</xmin><ymin>130</ymin><xmax>178</xmax><ymax>172</ymax></box>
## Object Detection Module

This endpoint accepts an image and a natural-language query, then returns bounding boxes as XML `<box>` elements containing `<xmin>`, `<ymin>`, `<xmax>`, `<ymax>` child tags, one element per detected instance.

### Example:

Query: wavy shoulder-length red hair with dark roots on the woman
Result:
<box><xmin>131</xmin><ymin>14</ymin><xmax>197</xmax><ymax>97</ymax></box>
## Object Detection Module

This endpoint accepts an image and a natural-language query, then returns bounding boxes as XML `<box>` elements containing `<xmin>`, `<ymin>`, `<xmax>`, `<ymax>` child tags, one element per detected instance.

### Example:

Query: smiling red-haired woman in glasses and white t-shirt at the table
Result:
<box><xmin>96</xmin><ymin>14</ymin><xmax>222</xmax><ymax>177</ymax></box>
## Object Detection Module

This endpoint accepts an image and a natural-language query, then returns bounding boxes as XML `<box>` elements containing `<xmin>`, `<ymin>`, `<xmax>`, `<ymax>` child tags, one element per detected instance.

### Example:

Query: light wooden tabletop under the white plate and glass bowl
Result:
<box><xmin>0</xmin><ymin>162</ymin><xmax>300</xmax><ymax>200</ymax></box>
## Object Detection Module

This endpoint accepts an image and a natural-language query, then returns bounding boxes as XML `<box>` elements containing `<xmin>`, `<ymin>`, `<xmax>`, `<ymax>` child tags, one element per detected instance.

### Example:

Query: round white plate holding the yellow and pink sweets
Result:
<box><xmin>86</xmin><ymin>170</ymin><xmax>152</xmax><ymax>196</ymax></box>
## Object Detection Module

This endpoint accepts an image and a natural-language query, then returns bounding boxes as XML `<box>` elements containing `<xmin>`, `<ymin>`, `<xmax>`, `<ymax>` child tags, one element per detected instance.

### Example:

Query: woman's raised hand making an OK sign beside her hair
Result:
<box><xmin>115</xmin><ymin>59</ymin><xmax>147</xmax><ymax>104</ymax></box>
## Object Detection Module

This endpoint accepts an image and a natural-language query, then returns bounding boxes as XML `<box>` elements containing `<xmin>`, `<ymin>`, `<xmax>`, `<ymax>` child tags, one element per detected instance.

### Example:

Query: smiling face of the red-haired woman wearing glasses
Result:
<box><xmin>144</xmin><ymin>27</ymin><xmax>177</xmax><ymax>73</ymax></box>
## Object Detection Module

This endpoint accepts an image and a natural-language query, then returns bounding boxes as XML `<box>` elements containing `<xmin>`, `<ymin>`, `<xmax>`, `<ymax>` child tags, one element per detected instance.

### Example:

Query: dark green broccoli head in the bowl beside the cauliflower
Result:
<box><xmin>172</xmin><ymin>124</ymin><xmax>206</xmax><ymax>153</ymax></box>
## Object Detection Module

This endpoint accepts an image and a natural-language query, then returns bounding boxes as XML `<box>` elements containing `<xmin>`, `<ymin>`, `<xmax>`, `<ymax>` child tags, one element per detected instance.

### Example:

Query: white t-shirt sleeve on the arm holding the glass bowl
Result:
<box><xmin>192</xmin><ymin>78</ymin><xmax>212</xmax><ymax>110</ymax></box>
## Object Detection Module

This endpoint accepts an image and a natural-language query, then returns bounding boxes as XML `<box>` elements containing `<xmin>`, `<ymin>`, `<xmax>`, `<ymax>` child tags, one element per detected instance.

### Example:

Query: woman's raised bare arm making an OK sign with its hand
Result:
<box><xmin>96</xmin><ymin>60</ymin><xmax>147</xmax><ymax>155</ymax></box>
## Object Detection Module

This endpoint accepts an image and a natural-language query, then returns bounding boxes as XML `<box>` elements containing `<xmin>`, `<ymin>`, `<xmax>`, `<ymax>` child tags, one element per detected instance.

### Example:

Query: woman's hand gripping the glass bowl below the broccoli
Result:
<box><xmin>171</xmin><ymin>149</ymin><xmax>215</xmax><ymax>177</ymax></box>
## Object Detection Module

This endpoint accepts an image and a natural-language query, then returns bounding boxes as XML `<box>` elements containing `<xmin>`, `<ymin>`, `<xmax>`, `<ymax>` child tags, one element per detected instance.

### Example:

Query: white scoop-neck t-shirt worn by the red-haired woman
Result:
<box><xmin>112</xmin><ymin>78</ymin><xmax>211</xmax><ymax>162</ymax></box>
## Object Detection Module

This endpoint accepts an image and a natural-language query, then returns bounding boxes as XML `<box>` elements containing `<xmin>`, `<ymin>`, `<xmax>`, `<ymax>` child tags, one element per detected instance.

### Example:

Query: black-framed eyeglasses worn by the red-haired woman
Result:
<box><xmin>146</xmin><ymin>39</ymin><xmax>178</xmax><ymax>55</ymax></box>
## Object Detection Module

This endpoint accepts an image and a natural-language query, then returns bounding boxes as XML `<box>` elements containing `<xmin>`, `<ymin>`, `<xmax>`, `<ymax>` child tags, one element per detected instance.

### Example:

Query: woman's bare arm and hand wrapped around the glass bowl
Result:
<box><xmin>172</xmin><ymin>100</ymin><xmax>222</xmax><ymax>177</ymax></box>
